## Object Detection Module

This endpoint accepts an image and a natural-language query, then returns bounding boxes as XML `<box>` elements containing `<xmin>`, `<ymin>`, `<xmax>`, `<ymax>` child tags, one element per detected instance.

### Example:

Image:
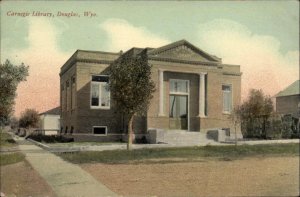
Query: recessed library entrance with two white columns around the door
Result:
<box><xmin>158</xmin><ymin>69</ymin><xmax>207</xmax><ymax>131</ymax></box>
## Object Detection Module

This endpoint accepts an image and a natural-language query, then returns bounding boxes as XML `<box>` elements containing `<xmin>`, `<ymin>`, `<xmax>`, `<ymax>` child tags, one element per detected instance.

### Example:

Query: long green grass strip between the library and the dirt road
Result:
<box><xmin>58</xmin><ymin>143</ymin><xmax>299</xmax><ymax>164</ymax></box>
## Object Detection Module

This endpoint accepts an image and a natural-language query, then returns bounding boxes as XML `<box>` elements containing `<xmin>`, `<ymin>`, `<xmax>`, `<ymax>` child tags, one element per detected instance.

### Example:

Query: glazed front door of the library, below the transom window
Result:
<box><xmin>169</xmin><ymin>95</ymin><xmax>188</xmax><ymax>130</ymax></box>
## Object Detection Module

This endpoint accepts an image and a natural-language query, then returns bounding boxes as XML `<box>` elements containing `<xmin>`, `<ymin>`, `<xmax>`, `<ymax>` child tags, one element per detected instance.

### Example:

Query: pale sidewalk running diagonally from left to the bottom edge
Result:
<box><xmin>15</xmin><ymin>138</ymin><xmax>117</xmax><ymax>197</ymax></box>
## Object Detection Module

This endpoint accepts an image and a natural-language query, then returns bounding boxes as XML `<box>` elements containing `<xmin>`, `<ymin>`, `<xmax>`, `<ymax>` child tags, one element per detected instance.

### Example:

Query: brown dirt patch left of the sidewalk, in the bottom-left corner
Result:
<box><xmin>0</xmin><ymin>161</ymin><xmax>55</xmax><ymax>197</ymax></box>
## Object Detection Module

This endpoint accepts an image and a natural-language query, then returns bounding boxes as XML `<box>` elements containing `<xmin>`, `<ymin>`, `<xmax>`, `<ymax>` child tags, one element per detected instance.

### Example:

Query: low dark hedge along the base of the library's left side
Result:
<box><xmin>28</xmin><ymin>134</ymin><xmax>74</xmax><ymax>143</ymax></box>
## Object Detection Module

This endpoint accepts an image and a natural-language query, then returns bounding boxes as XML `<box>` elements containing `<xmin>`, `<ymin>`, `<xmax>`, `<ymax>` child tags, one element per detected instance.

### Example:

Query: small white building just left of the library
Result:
<box><xmin>38</xmin><ymin>107</ymin><xmax>61</xmax><ymax>135</ymax></box>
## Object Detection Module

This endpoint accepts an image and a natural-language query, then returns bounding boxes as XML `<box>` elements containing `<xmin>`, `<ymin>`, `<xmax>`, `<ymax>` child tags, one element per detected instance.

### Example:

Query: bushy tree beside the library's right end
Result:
<box><xmin>237</xmin><ymin>89</ymin><xmax>274</xmax><ymax>138</ymax></box>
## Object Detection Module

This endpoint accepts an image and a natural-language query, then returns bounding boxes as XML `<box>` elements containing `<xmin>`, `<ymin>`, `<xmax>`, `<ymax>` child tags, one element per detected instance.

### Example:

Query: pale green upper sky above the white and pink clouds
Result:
<box><xmin>1</xmin><ymin>0</ymin><xmax>299</xmax><ymax>52</ymax></box>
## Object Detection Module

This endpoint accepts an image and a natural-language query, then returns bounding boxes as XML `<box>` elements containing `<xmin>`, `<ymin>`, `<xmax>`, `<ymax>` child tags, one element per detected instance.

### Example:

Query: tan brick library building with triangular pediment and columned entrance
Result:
<box><xmin>60</xmin><ymin>40</ymin><xmax>241</xmax><ymax>142</ymax></box>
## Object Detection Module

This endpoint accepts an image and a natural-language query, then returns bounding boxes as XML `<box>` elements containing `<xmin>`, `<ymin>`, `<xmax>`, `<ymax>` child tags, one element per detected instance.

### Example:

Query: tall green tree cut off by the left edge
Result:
<box><xmin>0</xmin><ymin>60</ymin><xmax>29</xmax><ymax>125</ymax></box>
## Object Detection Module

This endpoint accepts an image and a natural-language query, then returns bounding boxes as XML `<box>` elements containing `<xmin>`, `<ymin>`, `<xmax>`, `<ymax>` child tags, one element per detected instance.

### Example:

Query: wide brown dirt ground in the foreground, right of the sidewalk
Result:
<box><xmin>81</xmin><ymin>157</ymin><xmax>299</xmax><ymax>196</ymax></box>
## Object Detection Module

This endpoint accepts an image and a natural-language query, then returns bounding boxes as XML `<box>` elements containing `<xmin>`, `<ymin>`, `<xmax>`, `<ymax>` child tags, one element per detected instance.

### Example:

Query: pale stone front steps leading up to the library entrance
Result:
<box><xmin>149</xmin><ymin>129</ymin><xmax>216</xmax><ymax>145</ymax></box>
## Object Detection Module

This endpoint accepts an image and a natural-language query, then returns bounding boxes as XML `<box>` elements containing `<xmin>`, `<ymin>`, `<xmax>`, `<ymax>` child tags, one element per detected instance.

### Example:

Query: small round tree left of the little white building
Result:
<box><xmin>19</xmin><ymin>109</ymin><xmax>40</xmax><ymax>128</ymax></box>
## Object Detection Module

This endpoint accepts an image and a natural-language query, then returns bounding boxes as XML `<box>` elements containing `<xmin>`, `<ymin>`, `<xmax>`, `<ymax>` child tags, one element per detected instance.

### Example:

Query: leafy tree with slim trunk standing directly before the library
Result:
<box><xmin>109</xmin><ymin>52</ymin><xmax>155</xmax><ymax>150</ymax></box>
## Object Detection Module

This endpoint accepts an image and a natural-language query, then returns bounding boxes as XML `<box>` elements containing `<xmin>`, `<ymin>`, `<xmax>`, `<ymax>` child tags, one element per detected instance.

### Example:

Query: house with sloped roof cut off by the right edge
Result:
<box><xmin>275</xmin><ymin>80</ymin><xmax>300</xmax><ymax>118</ymax></box>
